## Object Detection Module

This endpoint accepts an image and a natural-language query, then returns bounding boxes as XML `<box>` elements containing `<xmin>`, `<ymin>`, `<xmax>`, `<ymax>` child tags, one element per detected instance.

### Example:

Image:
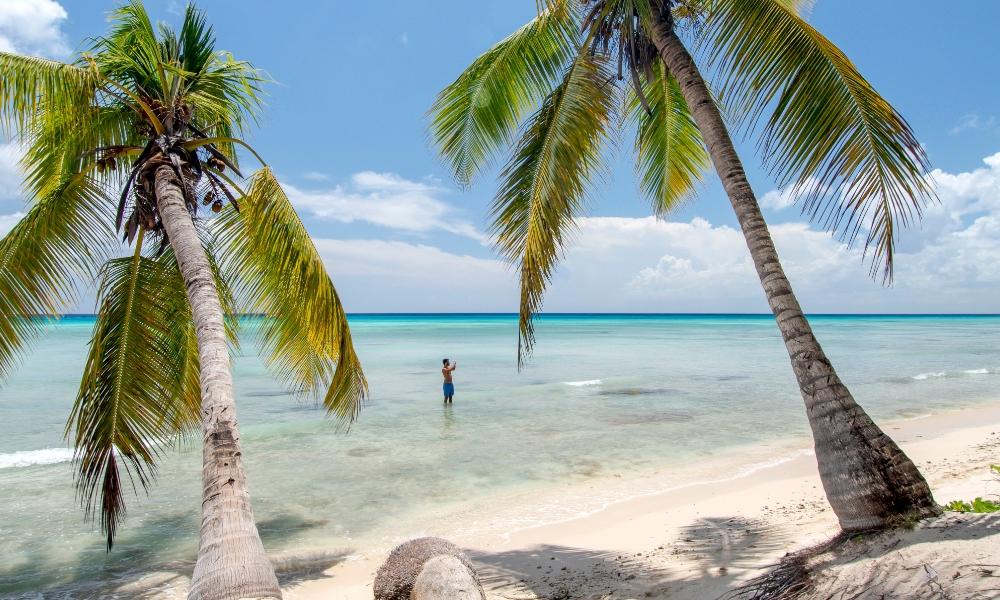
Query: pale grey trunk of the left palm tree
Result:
<box><xmin>155</xmin><ymin>165</ymin><xmax>281</xmax><ymax>600</ymax></box>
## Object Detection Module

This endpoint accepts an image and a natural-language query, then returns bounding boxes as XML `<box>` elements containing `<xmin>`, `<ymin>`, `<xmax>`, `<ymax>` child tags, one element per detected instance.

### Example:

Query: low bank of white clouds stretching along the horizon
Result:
<box><xmin>319</xmin><ymin>154</ymin><xmax>1000</xmax><ymax>312</ymax></box>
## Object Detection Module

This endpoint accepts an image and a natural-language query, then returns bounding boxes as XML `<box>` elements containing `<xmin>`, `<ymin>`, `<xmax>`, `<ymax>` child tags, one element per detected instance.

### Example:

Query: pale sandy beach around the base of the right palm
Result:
<box><xmin>284</xmin><ymin>402</ymin><xmax>1000</xmax><ymax>600</ymax></box>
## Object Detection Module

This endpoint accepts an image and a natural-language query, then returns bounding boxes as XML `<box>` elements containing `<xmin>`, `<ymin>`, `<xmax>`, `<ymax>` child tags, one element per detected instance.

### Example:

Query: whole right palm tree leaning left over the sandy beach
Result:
<box><xmin>431</xmin><ymin>0</ymin><xmax>937</xmax><ymax>531</ymax></box>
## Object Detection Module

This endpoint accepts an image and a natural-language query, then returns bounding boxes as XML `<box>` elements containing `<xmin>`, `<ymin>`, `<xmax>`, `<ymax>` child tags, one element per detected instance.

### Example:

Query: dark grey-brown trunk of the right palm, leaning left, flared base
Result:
<box><xmin>653</xmin><ymin>27</ymin><xmax>938</xmax><ymax>531</ymax></box>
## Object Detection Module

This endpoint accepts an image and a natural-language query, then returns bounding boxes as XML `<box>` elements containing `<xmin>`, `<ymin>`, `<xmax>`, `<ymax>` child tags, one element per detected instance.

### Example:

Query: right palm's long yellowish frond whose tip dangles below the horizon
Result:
<box><xmin>492</xmin><ymin>51</ymin><xmax>618</xmax><ymax>364</ymax></box>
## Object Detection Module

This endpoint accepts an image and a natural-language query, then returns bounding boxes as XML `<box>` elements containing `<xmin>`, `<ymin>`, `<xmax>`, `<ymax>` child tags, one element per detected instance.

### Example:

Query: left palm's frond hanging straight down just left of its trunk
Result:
<box><xmin>66</xmin><ymin>236</ymin><xmax>200</xmax><ymax>550</ymax></box>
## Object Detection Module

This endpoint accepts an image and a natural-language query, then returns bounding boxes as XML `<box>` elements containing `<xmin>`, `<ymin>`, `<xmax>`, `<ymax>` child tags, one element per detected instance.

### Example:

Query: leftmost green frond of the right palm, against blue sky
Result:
<box><xmin>430</xmin><ymin>2</ymin><xmax>578</xmax><ymax>185</ymax></box>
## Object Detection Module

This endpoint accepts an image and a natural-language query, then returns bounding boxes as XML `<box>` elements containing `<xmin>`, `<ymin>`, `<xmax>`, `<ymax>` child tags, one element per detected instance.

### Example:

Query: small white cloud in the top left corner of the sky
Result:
<box><xmin>0</xmin><ymin>0</ymin><xmax>70</xmax><ymax>58</ymax></box>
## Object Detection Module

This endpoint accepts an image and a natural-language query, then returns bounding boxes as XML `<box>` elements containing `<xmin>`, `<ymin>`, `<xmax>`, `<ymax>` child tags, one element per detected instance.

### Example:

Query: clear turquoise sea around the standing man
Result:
<box><xmin>0</xmin><ymin>315</ymin><xmax>1000</xmax><ymax>598</ymax></box>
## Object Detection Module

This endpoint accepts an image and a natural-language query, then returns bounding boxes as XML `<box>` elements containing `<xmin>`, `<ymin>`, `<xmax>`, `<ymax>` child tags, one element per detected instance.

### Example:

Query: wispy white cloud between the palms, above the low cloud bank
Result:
<box><xmin>285</xmin><ymin>171</ymin><xmax>486</xmax><ymax>242</ymax></box>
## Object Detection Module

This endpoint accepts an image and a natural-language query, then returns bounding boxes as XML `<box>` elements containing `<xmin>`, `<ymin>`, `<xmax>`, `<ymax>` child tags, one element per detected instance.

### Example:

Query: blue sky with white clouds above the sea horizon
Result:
<box><xmin>0</xmin><ymin>0</ymin><xmax>1000</xmax><ymax>312</ymax></box>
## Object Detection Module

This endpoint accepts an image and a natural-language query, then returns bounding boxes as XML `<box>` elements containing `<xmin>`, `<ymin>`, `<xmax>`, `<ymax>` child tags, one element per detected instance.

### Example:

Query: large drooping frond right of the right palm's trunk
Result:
<box><xmin>707</xmin><ymin>0</ymin><xmax>934</xmax><ymax>281</ymax></box>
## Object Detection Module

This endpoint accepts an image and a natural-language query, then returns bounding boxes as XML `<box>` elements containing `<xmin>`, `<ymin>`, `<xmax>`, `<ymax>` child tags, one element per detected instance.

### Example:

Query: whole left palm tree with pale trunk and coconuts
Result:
<box><xmin>0</xmin><ymin>0</ymin><xmax>367</xmax><ymax>600</ymax></box>
